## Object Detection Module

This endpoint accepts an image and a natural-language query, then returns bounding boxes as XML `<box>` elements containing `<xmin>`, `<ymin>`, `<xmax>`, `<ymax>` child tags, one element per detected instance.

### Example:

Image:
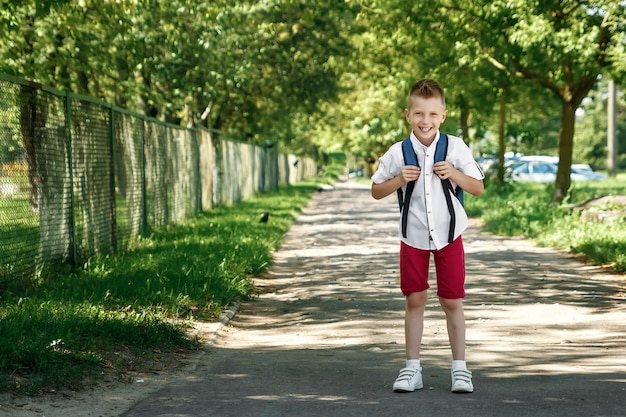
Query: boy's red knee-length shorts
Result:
<box><xmin>400</xmin><ymin>236</ymin><xmax>465</xmax><ymax>300</ymax></box>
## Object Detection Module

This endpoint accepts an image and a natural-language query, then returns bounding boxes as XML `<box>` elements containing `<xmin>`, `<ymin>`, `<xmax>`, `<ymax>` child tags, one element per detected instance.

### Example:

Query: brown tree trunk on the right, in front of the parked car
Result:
<box><xmin>552</xmin><ymin>99</ymin><xmax>576</xmax><ymax>203</ymax></box>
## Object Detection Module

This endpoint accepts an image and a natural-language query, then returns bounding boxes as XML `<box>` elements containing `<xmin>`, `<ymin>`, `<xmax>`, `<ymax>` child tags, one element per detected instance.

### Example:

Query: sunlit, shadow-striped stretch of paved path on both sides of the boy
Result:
<box><xmin>231</xmin><ymin>180</ymin><xmax>623</xmax><ymax>375</ymax></box>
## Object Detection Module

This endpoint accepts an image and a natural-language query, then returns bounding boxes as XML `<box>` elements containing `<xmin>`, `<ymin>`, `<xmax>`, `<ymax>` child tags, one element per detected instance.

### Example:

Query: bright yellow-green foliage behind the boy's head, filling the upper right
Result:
<box><xmin>342</xmin><ymin>0</ymin><xmax>626</xmax><ymax>199</ymax></box>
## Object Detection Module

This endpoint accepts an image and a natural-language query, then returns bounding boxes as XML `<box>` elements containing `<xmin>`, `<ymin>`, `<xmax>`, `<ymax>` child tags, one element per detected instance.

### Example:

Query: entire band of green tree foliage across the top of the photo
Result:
<box><xmin>0</xmin><ymin>0</ymin><xmax>626</xmax><ymax>190</ymax></box>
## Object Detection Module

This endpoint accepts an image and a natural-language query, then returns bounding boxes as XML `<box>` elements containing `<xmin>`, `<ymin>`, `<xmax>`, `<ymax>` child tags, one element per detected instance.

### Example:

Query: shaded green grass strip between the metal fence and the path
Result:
<box><xmin>0</xmin><ymin>172</ymin><xmax>335</xmax><ymax>393</ymax></box>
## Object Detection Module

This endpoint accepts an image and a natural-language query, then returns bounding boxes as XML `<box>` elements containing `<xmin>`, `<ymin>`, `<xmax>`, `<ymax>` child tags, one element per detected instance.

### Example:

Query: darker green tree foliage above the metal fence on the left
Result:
<box><xmin>0</xmin><ymin>0</ymin><xmax>356</xmax><ymax>153</ymax></box>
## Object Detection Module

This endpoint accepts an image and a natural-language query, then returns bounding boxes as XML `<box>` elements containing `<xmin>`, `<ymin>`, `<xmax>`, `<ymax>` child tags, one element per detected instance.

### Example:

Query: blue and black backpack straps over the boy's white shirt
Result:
<box><xmin>397</xmin><ymin>133</ymin><xmax>463</xmax><ymax>243</ymax></box>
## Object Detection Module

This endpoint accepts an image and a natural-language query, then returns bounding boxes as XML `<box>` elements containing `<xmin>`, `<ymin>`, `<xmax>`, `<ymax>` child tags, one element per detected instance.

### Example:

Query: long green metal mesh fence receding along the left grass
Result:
<box><xmin>0</xmin><ymin>75</ymin><xmax>317</xmax><ymax>286</ymax></box>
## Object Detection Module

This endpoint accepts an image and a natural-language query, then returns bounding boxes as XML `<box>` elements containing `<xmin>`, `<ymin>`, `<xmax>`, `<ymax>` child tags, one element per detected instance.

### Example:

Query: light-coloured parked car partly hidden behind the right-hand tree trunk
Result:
<box><xmin>506</xmin><ymin>155</ymin><xmax>606</xmax><ymax>183</ymax></box>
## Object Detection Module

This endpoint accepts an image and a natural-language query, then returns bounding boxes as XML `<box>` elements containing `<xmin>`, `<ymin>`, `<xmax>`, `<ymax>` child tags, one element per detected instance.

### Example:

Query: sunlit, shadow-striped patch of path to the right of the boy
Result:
<box><xmin>458</xmin><ymin>224</ymin><xmax>626</xmax><ymax>378</ymax></box>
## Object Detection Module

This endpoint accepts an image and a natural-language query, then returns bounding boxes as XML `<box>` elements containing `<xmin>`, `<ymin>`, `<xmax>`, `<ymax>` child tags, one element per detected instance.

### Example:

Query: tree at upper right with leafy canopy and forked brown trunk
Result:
<box><xmin>344</xmin><ymin>0</ymin><xmax>626</xmax><ymax>196</ymax></box>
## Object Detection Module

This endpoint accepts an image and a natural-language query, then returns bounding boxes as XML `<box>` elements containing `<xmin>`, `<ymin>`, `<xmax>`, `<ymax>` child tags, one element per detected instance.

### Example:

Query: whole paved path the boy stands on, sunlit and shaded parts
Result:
<box><xmin>123</xmin><ymin>183</ymin><xmax>626</xmax><ymax>417</ymax></box>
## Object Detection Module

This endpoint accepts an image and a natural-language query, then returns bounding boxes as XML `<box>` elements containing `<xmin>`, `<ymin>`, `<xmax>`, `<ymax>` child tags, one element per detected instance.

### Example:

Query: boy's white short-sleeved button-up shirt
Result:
<box><xmin>372</xmin><ymin>132</ymin><xmax>484</xmax><ymax>250</ymax></box>
